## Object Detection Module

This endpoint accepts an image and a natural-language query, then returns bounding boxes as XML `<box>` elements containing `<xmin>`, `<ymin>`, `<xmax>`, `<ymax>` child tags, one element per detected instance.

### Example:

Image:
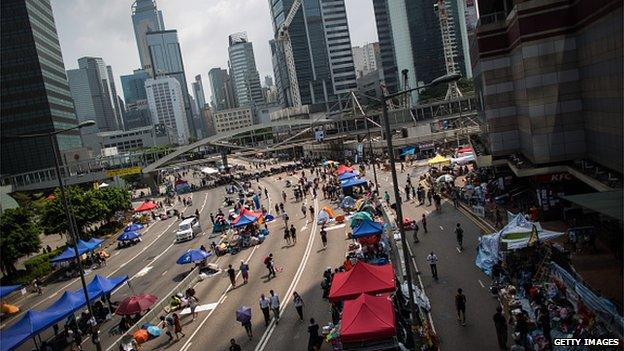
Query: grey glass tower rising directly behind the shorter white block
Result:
<box><xmin>147</xmin><ymin>29</ymin><xmax>197</xmax><ymax>137</ymax></box>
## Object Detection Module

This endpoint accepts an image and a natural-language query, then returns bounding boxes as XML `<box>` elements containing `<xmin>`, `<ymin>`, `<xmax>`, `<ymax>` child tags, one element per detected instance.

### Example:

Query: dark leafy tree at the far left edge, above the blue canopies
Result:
<box><xmin>0</xmin><ymin>207</ymin><xmax>41</xmax><ymax>275</ymax></box>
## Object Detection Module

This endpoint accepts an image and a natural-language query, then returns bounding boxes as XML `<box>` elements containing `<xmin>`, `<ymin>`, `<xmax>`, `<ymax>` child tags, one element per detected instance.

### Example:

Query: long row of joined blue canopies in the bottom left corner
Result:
<box><xmin>0</xmin><ymin>275</ymin><xmax>128</xmax><ymax>351</ymax></box>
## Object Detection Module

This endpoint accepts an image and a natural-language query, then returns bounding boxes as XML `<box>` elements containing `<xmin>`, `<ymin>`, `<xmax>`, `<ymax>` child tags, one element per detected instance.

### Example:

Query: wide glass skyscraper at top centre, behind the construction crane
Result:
<box><xmin>270</xmin><ymin>0</ymin><xmax>356</xmax><ymax>108</ymax></box>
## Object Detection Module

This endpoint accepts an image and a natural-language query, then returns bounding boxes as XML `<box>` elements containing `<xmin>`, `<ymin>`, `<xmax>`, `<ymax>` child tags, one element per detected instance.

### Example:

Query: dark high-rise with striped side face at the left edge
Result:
<box><xmin>0</xmin><ymin>0</ymin><xmax>82</xmax><ymax>175</ymax></box>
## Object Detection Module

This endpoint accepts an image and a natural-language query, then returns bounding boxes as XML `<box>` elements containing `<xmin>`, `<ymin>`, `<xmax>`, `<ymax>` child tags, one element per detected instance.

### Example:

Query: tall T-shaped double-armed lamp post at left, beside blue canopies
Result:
<box><xmin>16</xmin><ymin>120</ymin><xmax>101</xmax><ymax>350</ymax></box>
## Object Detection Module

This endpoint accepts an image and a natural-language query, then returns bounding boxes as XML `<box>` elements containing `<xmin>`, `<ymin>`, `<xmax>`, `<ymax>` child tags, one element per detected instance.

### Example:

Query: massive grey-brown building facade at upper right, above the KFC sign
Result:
<box><xmin>471</xmin><ymin>0</ymin><xmax>624</xmax><ymax>172</ymax></box>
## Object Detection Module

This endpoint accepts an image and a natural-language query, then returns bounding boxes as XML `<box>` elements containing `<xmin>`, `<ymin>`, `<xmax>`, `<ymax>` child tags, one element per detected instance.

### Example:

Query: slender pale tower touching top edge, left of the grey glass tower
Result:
<box><xmin>132</xmin><ymin>0</ymin><xmax>165</xmax><ymax>75</ymax></box>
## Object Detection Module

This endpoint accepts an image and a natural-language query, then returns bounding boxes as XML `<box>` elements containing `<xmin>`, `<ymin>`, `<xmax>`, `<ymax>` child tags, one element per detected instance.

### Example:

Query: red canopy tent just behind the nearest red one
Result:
<box><xmin>329</xmin><ymin>261</ymin><xmax>396</xmax><ymax>302</ymax></box>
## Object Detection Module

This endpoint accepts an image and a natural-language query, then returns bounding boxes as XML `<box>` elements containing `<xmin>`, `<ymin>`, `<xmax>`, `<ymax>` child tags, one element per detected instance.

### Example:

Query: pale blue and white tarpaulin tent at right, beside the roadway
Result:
<box><xmin>475</xmin><ymin>213</ymin><xmax>565</xmax><ymax>275</ymax></box>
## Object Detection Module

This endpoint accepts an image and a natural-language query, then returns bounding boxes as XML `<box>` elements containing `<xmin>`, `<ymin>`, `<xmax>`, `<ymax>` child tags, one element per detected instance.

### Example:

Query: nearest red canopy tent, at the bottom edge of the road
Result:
<box><xmin>340</xmin><ymin>294</ymin><xmax>396</xmax><ymax>342</ymax></box>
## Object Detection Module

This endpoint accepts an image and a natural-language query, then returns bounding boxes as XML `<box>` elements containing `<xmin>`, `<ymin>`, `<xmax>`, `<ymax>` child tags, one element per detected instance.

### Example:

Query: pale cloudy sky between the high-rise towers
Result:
<box><xmin>52</xmin><ymin>0</ymin><xmax>377</xmax><ymax>100</ymax></box>
